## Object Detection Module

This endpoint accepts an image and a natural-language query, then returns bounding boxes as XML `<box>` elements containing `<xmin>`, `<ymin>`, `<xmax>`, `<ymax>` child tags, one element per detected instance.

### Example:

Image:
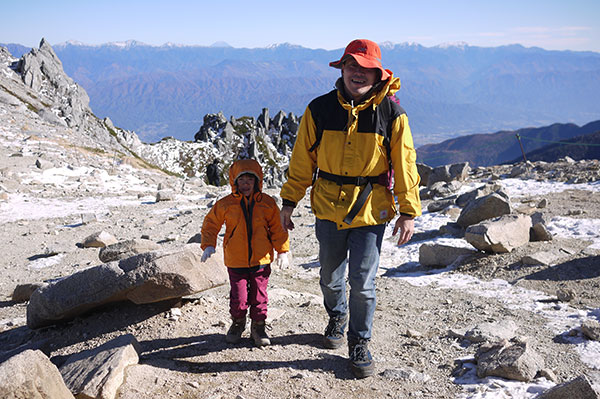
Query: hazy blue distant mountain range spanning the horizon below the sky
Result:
<box><xmin>4</xmin><ymin>41</ymin><xmax>600</xmax><ymax>146</ymax></box>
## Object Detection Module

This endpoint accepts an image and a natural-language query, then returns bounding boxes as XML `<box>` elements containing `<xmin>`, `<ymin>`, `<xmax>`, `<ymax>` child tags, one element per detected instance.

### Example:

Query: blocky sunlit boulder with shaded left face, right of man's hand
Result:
<box><xmin>465</xmin><ymin>215</ymin><xmax>531</xmax><ymax>253</ymax></box>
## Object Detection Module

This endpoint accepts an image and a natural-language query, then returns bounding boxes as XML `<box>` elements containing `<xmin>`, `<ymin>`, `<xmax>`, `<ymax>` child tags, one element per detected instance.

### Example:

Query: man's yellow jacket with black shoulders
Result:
<box><xmin>281</xmin><ymin>75</ymin><xmax>421</xmax><ymax>229</ymax></box>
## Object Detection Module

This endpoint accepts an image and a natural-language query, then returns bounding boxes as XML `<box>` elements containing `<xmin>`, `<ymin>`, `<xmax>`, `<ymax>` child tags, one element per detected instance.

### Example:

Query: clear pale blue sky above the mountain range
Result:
<box><xmin>0</xmin><ymin>0</ymin><xmax>600</xmax><ymax>52</ymax></box>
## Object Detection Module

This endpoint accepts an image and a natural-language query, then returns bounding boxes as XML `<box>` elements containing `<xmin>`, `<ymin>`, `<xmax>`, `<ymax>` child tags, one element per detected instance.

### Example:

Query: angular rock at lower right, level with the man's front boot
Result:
<box><xmin>475</xmin><ymin>339</ymin><xmax>544</xmax><ymax>382</ymax></box>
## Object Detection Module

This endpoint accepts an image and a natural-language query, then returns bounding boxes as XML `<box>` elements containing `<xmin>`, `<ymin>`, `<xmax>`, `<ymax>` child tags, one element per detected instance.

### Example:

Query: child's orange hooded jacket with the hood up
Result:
<box><xmin>201</xmin><ymin>159</ymin><xmax>290</xmax><ymax>268</ymax></box>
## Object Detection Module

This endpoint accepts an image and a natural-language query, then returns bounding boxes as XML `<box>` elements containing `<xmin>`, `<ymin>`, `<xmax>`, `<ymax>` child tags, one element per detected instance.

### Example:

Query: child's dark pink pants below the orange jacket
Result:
<box><xmin>227</xmin><ymin>265</ymin><xmax>271</xmax><ymax>321</ymax></box>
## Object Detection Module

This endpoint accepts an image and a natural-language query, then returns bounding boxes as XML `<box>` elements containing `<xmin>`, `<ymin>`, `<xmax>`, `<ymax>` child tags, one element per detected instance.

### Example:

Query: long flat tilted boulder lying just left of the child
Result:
<box><xmin>27</xmin><ymin>244</ymin><xmax>228</xmax><ymax>328</ymax></box>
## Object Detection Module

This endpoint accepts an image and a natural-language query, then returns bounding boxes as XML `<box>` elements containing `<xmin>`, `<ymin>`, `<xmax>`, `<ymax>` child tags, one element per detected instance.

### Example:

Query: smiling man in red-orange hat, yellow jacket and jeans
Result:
<box><xmin>281</xmin><ymin>39</ymin><xmax>421</xmax><ymax>378</ymax></box>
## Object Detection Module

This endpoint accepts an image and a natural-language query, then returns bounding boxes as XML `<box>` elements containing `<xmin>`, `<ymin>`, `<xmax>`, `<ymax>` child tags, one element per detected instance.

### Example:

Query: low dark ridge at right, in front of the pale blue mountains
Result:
<box><xmin>417</xmin><ymin>120</ymin><xmax>600</xmax><ymax>166</ymax></box>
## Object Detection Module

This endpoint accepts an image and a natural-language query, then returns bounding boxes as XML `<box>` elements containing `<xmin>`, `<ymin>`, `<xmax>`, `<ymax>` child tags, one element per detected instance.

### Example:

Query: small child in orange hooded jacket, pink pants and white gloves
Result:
<box><xmin>201</xmin><ymin>159</ymin><xmax>290</xmax><ymax>346</ymax></box>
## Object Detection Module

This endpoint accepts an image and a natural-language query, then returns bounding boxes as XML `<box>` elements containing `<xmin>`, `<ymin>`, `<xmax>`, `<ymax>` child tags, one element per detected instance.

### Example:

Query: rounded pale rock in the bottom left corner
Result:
<box><xmin>0</xmin><ymin>349</ymin><xmax>74</xmax><ymax>399</ymax></box>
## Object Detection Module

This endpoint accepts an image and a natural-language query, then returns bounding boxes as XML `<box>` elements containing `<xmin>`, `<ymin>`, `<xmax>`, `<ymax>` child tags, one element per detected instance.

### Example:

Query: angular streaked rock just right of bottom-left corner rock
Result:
<box><xmin>60</xmin><ymin>334</ymin><xmax>140</xmax><ymax>399</ymax></box>
